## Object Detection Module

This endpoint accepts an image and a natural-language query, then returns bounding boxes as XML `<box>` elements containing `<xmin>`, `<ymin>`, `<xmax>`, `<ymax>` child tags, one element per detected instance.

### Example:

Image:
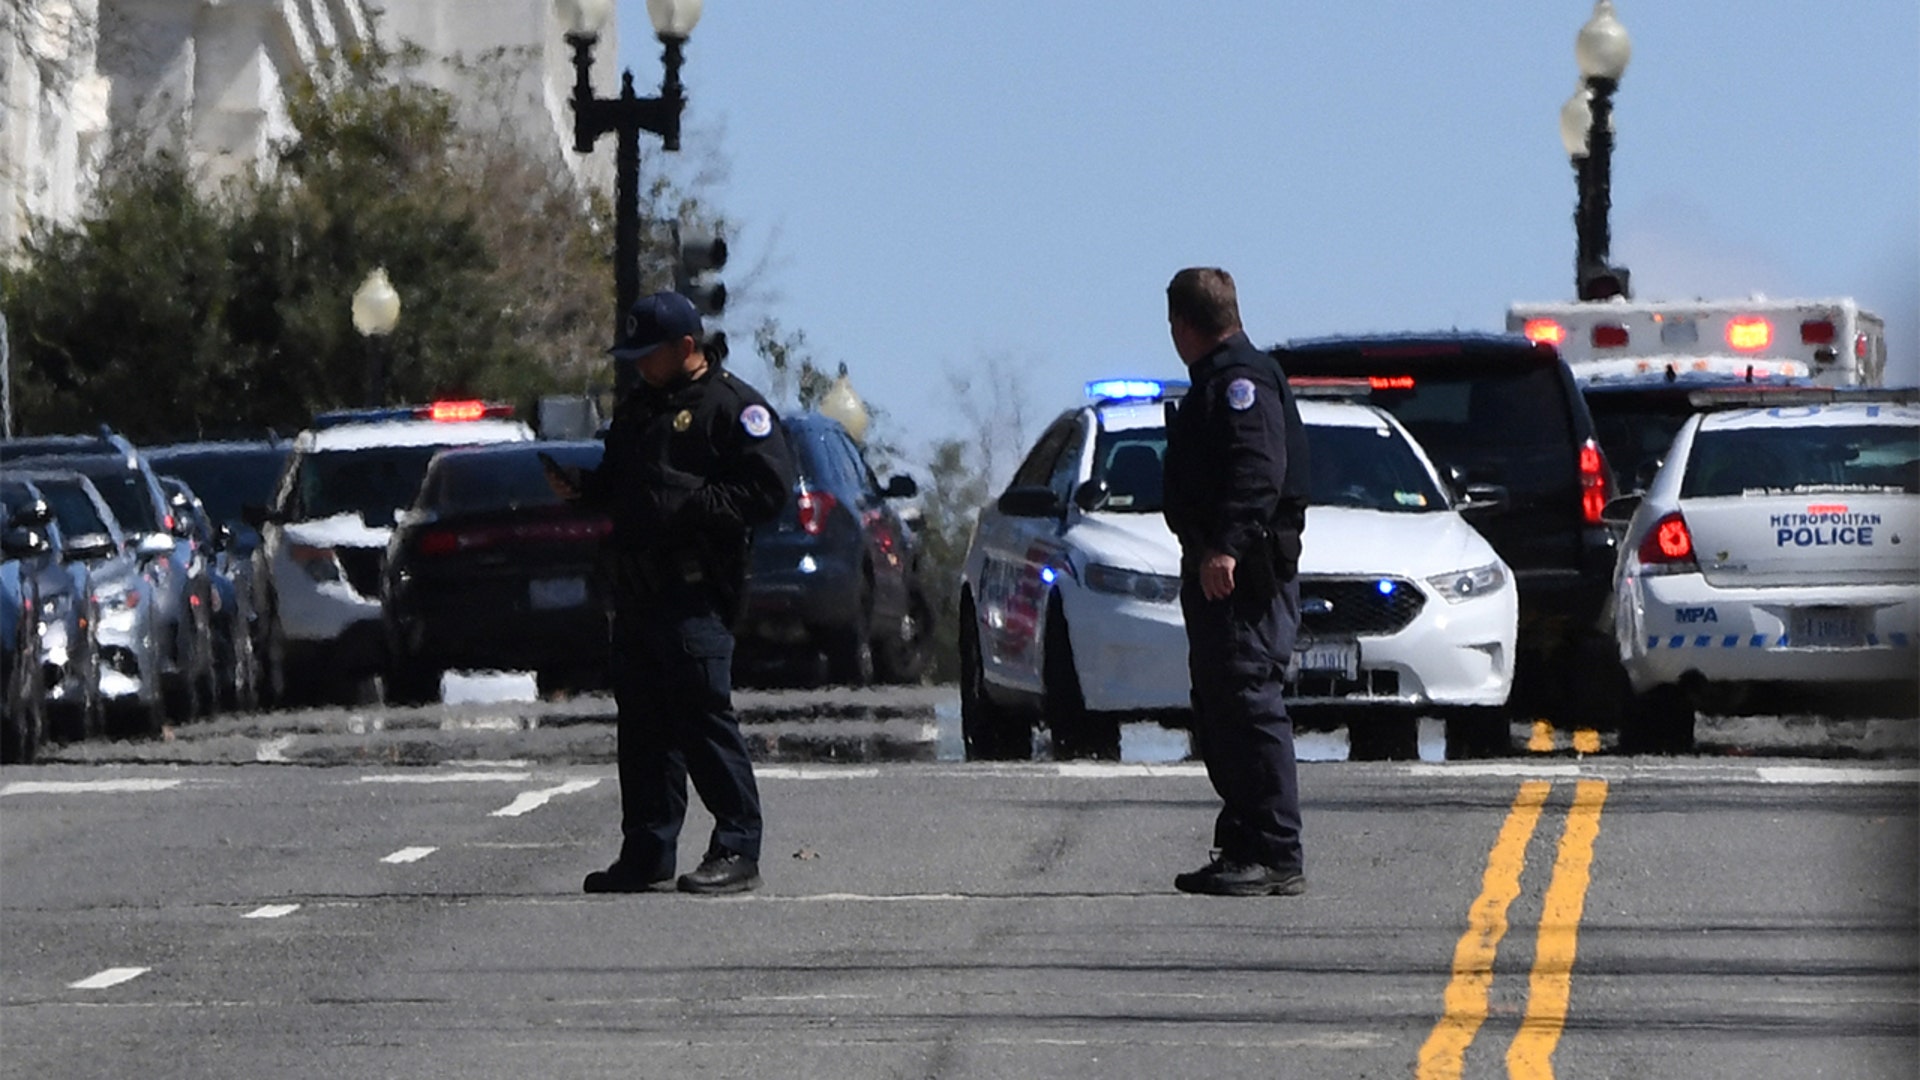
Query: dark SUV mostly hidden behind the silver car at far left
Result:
<box><xmin>0</xmin><ymin>427</ymin><xmax>213</xmax><ymax>721</ymax></box>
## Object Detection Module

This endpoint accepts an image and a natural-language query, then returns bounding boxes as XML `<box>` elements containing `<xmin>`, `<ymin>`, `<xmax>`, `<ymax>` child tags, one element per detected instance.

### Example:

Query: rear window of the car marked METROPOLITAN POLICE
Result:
<box><xmin>1680</xmin><ymin>425</ymin><xmax>1920</xmax><ymax>498</ymax></box>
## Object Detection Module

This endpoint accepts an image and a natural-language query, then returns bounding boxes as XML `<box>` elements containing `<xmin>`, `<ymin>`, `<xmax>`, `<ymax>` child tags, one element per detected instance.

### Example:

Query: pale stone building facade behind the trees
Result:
<box><xmin>0</xmin><ymin>0</ymin><xmax>618</xmax><ymax>254</ymax></box>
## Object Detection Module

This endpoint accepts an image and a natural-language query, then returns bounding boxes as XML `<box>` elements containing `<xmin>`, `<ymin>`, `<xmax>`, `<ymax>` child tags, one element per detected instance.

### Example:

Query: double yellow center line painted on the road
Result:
<box><xmin>1415</xmin><ymin>780</ymin><xmax>1607</xmax><ymax>1080</ymax></box>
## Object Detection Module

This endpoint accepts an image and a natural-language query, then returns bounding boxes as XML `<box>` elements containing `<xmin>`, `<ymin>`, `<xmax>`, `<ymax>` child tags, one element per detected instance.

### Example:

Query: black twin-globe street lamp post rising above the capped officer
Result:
<box><xmin>553</xmin><ymin>0</ymin><xmax>703</xmax><ymax>349</ymax></box>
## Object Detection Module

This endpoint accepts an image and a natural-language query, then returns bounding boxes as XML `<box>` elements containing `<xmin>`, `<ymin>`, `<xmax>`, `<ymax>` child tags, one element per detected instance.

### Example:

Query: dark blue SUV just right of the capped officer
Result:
<box><xmin>735</xmin><ymin>413</ymin><xmax>933</xmax><ymax>686</ymax></box>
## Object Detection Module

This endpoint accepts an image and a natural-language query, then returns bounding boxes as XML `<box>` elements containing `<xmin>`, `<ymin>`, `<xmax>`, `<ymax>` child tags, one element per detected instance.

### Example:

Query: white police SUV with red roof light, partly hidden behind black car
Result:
<box><xmin>253</xmin><ymin>402</ymin><xmax>534</xmax><ymax>701</ymax></box>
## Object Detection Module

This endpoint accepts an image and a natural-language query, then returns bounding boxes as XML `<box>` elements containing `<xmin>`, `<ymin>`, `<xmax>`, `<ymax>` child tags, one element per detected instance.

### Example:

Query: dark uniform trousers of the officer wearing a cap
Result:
<box><xmin>612</xmin><ymin>598</ymin><xmax>760</xmax><ymax>878</ymax></box>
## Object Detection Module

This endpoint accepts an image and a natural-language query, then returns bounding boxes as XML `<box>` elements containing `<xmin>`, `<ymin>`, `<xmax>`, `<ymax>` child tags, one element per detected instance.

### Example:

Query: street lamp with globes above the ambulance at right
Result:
<box><xmin>1561</xmin><ymin>0</ymin><xmax>1634</xmax><ymax>300</ymax></box>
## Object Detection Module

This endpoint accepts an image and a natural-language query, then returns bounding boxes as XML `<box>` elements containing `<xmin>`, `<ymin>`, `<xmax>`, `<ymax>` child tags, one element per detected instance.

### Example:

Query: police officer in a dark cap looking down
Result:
<box><xmin>549</xmin><ymin>292</ymin><xmax>793</xmax><ymax>894</ymax></box>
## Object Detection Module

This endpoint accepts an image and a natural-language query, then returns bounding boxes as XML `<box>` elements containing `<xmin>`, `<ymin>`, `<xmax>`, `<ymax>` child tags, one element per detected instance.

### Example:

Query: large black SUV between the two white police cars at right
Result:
<box><xmin>1273</xmin><ymin>332</ymin><xmax>1626</xmax><ymax>755</ymax></box>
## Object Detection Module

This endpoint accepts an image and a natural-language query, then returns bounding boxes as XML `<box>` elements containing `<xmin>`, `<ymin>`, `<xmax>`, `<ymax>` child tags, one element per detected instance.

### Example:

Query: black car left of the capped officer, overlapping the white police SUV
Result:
<box><xmin>380</xmin><ymin>442</ymin><xmax>612</xmax><ymax>705</ymax></box>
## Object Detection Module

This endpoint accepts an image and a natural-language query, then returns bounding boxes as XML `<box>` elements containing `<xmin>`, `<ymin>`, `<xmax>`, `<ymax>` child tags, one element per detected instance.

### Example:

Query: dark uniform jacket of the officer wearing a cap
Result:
<box><xmin>580</xmin><ymin>367</ymin><xmax>793</xmax><ymax>621</ymax></box>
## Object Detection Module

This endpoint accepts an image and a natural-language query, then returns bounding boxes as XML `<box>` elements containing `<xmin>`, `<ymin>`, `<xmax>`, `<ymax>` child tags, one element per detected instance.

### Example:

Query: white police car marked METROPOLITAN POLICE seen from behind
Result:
<box><xmin>1609</xmin><ymin>390</ymin><xmax>1920</xmax><ymax>751</ymax></box>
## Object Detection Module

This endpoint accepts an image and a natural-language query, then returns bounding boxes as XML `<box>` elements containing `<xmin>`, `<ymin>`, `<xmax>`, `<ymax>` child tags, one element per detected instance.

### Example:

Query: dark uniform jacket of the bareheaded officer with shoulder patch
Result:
<box><xmin>1165</xmin><ymin>332</ymin><xmax>1308</xmax><ymax>580</ymax></box>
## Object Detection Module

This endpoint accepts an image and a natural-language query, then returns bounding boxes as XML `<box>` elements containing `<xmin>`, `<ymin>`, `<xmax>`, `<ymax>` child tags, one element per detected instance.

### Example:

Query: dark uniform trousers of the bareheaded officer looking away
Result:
<box><xmin>1181</xmin><ymin>569</ymin><xmax>1304</xmax><ymax>871</ymax></box>
